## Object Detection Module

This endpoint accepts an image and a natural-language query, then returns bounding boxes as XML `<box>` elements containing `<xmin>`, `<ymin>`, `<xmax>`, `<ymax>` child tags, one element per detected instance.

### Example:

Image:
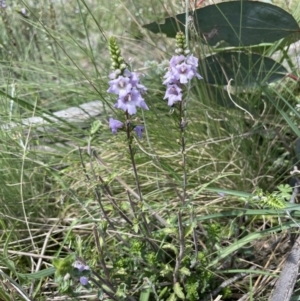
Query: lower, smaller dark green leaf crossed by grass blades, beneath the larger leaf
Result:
<box><xmin>203</xmin><ymin>51</ymin><xmax>288</xmax><ymax>87</ymax></box>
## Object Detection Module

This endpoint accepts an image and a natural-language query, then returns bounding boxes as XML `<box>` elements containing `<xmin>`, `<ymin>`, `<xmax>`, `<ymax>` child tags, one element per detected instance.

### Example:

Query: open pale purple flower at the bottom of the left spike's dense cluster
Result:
<box><xmin>115</xmin><ymin>88</ymin><xmax>149</xmax><ymax>115</ymax></box>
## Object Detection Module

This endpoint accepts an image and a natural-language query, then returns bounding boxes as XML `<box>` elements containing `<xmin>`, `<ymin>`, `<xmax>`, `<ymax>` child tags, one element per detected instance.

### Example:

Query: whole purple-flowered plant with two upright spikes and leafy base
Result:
<box><xmin>55</xmin><ymin>32</ymin><xmax>208</xmax><ymax>300</ymax></box>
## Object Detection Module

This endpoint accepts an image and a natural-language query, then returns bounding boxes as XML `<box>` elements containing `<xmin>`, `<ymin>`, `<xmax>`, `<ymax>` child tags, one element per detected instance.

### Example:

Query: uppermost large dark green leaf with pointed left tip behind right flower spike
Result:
<box><xmin>144</xmin><ymin>1</ymin><xmax>299</xmax><ymax>46</ymax></box>
